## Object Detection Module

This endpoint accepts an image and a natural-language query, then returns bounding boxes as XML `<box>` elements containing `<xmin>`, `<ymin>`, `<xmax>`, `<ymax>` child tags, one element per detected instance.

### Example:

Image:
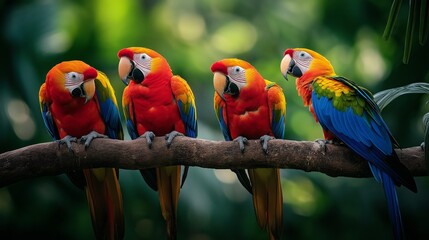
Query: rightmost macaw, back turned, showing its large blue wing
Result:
<box><xmin>280</xmin><ymin>48</ymin><xmax>417</xmax><ymax>239</ymax></box>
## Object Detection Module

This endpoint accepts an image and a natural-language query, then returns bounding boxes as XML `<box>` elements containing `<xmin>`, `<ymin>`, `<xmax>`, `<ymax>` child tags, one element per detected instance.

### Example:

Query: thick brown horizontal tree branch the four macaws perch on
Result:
<box><xmin>0</xmin><ymin>137</ymin><xmax>428</xmax><ymax>187</ymax></box>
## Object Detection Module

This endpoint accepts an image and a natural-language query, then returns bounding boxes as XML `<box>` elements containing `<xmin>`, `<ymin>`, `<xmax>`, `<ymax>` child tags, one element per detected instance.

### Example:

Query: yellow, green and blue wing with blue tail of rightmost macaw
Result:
<box><xmin>312</xmin><ymin>77</ymin><xmax>417</xmax><ymax>239</ymax></box>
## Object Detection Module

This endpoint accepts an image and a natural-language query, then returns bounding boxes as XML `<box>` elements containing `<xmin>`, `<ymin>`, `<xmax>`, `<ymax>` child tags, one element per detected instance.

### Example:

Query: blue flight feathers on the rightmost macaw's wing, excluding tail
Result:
<box><xmin>312</xmin><ymin>91</ymin><xmax>416</xmax><ymax>190</ymax></box>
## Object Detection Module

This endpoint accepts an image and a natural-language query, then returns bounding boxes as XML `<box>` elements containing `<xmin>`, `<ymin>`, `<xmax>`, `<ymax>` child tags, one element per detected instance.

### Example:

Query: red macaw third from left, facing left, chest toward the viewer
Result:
<box><xmin>211</xmin><ymin>59</ymin><xmax>286</xmax><ymax>239</ymax></box>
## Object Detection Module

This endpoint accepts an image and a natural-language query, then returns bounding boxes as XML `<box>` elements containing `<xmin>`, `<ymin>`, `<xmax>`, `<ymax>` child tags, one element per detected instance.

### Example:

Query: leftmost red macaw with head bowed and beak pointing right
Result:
<box><xmin>39</xmin><ymin>61</ymin><xmax>124</xmax><ymax>239</ymax></box>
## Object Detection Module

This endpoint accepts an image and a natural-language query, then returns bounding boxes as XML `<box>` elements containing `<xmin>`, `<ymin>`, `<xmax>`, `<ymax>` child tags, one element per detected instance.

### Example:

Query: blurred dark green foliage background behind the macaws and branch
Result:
<box><xmin>0</xmin><ymin>0</ymin><xmax>429</xmax><ymax>240</ymax></box>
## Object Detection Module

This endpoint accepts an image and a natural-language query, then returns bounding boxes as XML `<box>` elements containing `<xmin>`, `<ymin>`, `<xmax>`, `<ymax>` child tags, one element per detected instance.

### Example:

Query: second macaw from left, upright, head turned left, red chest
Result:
<box><xmin>118</xmin><ymin>47</ymin><xmax>197</xmax><ymax>239</ymax></box>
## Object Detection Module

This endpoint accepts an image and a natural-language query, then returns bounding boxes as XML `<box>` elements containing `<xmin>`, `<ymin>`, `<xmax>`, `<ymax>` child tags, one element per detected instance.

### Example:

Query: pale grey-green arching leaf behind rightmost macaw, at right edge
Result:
<box><xmin>374</xmin><ymin>82</ymin><xmax>429</xmax><ymax>110</ymax></box>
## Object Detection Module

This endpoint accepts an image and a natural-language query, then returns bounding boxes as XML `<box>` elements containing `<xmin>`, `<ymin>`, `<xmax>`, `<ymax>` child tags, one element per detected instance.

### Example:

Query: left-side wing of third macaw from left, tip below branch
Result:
<box><xmin>213</xmin><ymin>92</ymin><xmax>252</xmax><ymax>194</ymax></box>
